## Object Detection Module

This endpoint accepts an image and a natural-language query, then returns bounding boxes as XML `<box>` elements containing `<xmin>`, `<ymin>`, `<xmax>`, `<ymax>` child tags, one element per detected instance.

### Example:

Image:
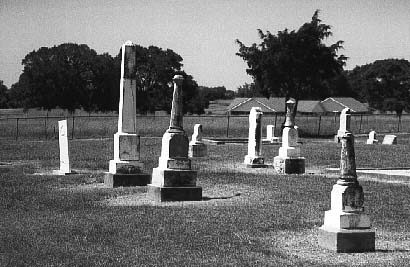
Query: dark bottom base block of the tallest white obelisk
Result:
<box><xmin>104</xmin><ymin>172</ymin><xmax>151</xmax><ymax>188</ymax></box>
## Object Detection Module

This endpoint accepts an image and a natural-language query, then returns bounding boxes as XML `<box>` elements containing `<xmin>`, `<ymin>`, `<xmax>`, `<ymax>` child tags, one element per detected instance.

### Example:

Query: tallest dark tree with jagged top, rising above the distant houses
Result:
<box><xmin>236</xmin><ymin>10</ymin><xmax>347</xmax><ymax>114</ymax></box>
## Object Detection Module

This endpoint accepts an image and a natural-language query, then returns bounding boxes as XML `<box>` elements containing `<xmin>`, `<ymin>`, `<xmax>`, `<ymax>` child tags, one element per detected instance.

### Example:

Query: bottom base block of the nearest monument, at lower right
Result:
<box><xmin>318</xmin><ymin>226</ymin><xmax>375</xmax><ymax>253</ymax></box>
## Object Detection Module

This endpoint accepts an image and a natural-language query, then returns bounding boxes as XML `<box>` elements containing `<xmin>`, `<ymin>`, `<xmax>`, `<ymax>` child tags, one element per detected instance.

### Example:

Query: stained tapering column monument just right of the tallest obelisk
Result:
<box><xmin>148</xmin><ymin>75</ymin><xmax>202</xmax><ymax>202</ymax></box>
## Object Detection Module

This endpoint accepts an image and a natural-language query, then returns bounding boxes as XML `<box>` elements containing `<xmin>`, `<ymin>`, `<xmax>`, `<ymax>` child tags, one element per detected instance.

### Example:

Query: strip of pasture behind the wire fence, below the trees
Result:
<box><xmin>0</xmin><ymin>114</ymin><xmax>410</xmax><ymax>140</ymax></box>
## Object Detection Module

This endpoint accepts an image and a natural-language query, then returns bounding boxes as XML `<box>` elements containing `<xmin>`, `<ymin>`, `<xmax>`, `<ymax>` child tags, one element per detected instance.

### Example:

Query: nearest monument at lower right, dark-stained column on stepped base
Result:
<box><xmin>318</xmin><ymin>110</ymin><xmax>375</xmax><ymax>252</ymax></box>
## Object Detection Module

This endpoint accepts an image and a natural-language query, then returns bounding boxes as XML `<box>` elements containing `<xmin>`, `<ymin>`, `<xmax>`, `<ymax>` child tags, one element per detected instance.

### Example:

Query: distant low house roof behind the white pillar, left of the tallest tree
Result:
<box><xmin>227</xmin><ymin>97</ymin><xmax>286</xmax><ymax>115</ymax></box>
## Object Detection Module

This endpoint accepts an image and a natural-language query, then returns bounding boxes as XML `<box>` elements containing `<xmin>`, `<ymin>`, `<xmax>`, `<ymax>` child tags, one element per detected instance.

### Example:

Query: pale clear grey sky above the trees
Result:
<box><xmin>0</xmin><ymin>0</ymin><xmax>410</xmax><ymax>90</ymax></box>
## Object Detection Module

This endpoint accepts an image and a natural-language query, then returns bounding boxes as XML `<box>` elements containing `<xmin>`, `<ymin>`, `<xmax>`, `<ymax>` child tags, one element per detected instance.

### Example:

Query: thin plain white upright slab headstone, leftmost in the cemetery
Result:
<box><xmin>53</xmin><ymin>120</ymin><xmax>72</xmax><ymax>175</ymax></box>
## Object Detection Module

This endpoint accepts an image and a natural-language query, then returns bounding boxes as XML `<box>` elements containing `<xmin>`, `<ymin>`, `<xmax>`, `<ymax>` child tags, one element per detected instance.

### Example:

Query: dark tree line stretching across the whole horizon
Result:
<box><xmin>0</xmin><ymin>11</ymin><xmax>410</xmax><ymax>115</ymax></box>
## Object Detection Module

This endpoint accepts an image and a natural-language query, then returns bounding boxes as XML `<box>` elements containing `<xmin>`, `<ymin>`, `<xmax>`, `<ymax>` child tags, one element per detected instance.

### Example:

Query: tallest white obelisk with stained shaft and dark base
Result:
<box><xmin>104</xmin><ymin>41</ymin><xmax>150</xmax><ymax>187</ymax></box>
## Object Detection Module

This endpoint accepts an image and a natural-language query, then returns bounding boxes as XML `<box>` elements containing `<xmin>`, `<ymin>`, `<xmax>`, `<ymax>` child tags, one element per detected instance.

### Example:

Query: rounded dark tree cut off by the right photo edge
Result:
<box><xmin>347</xmin><ymin>59</ymin><xmax>410</xmax><ymax>116</ymax></box>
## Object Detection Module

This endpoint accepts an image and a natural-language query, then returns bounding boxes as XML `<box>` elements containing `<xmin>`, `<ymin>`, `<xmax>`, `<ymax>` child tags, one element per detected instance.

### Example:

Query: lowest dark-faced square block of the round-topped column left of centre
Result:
<box><xmin>147</xmin><ymin>184</ymin><xmax>202</xmax><ymax>202</ymax></box>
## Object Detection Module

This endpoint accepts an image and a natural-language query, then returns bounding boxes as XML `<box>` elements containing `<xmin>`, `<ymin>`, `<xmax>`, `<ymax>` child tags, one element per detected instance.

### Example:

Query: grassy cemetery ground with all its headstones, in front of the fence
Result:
<box><xmin>0</xmin><ymin>42</ymin><xmax>410</xmax><ymax>266</ymax></box>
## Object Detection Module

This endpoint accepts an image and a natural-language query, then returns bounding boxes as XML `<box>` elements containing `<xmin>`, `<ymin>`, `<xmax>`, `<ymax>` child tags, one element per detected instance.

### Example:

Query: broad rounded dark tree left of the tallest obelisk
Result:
<box><xmin>12</xmin><ymin>43</ymin><xmax>107</xmax><ymax>112</ymax></box>
